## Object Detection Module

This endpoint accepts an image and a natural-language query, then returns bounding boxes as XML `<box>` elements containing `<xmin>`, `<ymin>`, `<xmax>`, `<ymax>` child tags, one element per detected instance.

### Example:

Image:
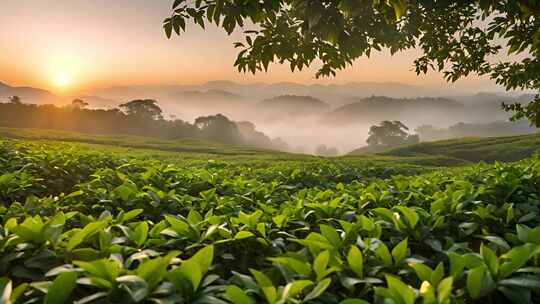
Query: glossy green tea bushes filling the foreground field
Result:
<box><xmin>0</xmin><ymin>130</ymin><xmax>540</xmax><ymax>304</ymax></box>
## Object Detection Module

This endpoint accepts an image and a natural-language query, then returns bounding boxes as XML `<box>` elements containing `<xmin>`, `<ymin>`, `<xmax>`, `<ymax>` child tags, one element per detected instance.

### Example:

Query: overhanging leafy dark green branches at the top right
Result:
<box><xmin>164</xmin><ymin>0</ymin><xmax>540</xmax><ymax>123</ymax></box>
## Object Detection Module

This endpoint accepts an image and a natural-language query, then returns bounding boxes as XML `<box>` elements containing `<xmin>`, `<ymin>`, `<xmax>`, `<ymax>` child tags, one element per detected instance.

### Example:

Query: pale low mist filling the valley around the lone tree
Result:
<box><xmin>154</xmin><ymin>91</ymin><xmax>534</xmax><ymax>155</ymax></box>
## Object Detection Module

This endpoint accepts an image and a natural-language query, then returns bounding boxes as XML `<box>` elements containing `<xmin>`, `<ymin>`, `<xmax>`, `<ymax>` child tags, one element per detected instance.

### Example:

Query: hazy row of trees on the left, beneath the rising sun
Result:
<box><xmin>0</xmin><ymin>100</ymin><xmax>287</xmax><ymax>150</ymax></box>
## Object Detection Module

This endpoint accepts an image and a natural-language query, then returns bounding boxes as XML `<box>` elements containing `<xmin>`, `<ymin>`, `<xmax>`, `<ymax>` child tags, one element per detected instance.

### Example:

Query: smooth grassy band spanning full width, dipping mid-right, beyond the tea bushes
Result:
<box><xmin>0</xmin><ymin>128</ymin><xmax>540</xmax><ymax>168</ymax></box>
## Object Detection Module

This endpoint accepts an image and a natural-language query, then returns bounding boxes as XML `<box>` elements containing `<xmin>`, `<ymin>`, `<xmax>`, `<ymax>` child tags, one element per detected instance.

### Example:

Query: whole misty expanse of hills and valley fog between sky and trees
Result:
<box><xmin>0</xmin><ymin>81</ymin><xmax>534</xmax><ymax>154</ymax></box>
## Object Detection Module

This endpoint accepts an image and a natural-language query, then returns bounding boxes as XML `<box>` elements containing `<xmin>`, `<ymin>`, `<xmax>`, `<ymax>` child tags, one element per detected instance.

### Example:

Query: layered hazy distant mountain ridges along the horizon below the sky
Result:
<box><xmin>0</xmin><ymin>80</ymin><xmax>534</xmax><ymax>124</ymax></box>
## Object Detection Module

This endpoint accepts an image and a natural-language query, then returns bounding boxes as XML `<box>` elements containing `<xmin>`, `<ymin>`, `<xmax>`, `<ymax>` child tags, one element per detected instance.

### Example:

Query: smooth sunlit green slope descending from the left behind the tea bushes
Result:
<box><xmin>0</xmin><ymin>128</ymin><xmax>470</xmax><ymax>171</ymax></box>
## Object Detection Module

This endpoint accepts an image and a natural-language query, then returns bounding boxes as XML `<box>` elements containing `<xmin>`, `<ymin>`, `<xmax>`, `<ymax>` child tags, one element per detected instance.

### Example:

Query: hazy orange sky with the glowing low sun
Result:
<box><xmin>0</xmin><ymin>0</ymin><xmax>502</xmax><ymax>94</ymax></box>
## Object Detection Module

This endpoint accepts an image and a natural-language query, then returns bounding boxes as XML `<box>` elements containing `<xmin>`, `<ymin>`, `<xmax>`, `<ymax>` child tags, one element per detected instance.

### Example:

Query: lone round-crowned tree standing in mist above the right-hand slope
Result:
<box><xmin>366</xmin><ymin>120</ymin><xmax>420</xmax><ymax>147</ymax></box>
